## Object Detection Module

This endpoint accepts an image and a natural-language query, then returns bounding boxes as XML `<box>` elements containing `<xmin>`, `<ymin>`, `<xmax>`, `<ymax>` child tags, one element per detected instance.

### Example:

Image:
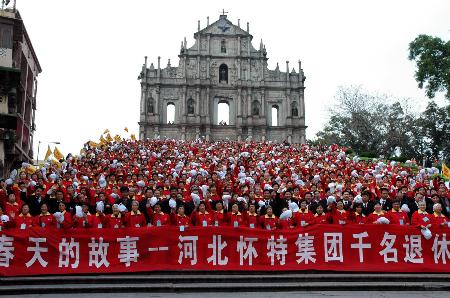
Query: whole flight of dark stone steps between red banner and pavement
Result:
<box><xmin>0</xmin><ymin>271</ymin><xmax>450</xmax><ymax>296</ymax></box>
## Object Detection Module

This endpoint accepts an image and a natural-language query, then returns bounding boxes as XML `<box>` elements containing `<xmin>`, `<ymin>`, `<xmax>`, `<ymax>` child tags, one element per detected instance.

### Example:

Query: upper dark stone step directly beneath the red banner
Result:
<box><xmin>0</xmin><ymin>271</ymin><xmax>450</xmax><ymax>285</ymax></box>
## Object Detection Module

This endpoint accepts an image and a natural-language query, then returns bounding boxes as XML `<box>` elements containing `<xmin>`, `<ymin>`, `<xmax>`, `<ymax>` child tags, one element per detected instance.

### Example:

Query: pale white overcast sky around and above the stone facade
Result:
<box><xmin>12</xmin><ymin>0</ymin><xmax>450</xmax><ymax>158</ymax></box>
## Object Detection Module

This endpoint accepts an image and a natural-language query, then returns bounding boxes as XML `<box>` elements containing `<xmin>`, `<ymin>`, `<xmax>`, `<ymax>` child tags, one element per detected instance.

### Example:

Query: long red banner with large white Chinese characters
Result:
<box><xmin>0</xmin><ymin>225</ymin><xmax>450</xmax><ymax>276</ymax></box>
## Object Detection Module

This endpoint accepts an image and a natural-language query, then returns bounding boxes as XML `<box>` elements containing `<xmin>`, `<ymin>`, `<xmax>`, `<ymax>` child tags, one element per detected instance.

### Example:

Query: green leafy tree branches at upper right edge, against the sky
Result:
<box><xmin>409</xmin><ymin>35</ymin><xmax>450</xmax><ymax>100</ymax></box>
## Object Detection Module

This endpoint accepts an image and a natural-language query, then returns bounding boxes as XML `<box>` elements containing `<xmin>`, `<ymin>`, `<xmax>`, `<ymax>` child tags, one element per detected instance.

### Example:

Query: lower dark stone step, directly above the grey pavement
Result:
<box><xmin>0</xmin><ymin>281</ymin><xmax>450</xmax><ymax>295</ymax></box>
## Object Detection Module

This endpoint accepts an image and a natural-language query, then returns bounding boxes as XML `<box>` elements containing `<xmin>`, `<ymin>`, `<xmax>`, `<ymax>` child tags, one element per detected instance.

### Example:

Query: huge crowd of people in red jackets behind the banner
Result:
<box><xmin>0</xmin><ymin>140</ymin><xmax>450</xmax><ymax>230</ymax></box>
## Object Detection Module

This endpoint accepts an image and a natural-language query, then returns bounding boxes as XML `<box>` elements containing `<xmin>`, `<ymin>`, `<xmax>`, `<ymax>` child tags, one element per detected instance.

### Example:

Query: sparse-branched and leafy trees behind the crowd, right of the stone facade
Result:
<box><xmin>315</xmin><ymin>86</ymin><xmax>450</xmax><ymax>162</ymax></box>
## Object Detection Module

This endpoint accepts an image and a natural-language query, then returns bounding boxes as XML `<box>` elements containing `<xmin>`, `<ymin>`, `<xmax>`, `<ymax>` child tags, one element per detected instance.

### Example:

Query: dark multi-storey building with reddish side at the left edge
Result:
<box><xmin>0</xmin><ymin>8</ymin><xmax>41</xmax><ymax>178</ymax></box>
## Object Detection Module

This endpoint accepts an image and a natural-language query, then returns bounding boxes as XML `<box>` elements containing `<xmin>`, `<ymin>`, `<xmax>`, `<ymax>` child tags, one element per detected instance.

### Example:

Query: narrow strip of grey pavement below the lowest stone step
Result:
<box><xmin>12</xmin><ymin>291</ymin><xmax>449</xmax><ymax>298</ymax></box>
